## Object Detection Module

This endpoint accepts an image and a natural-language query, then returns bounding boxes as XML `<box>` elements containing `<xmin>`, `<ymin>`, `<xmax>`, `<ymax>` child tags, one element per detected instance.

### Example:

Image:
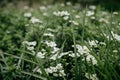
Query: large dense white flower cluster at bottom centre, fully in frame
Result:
<box><xmin>45</xmin><ymin>63</ymin><xmax>66</xmax><ymax>77</ymax></box>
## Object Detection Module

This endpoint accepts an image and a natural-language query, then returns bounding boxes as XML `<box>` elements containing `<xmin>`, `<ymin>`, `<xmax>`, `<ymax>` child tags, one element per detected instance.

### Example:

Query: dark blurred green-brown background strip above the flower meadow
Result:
<box><xmin>0</xmin><ymin>0</ymin><xmax>120</xmax><ymax>11</ymax></box>
